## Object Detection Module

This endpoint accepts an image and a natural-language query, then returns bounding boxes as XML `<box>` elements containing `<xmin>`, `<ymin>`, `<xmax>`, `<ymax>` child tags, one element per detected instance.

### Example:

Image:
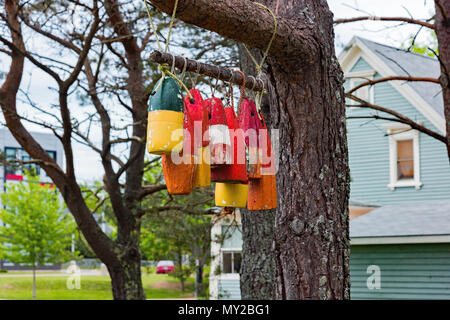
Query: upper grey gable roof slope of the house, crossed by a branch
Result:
<box><xmin>355</xmin><ymin>37</ymin><xmax>444</xmax><ymax>118</ymax></box>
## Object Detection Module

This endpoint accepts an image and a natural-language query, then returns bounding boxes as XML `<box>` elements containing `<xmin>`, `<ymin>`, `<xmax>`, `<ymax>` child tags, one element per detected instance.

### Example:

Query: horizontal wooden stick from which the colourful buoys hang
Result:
<box><xmin>150</xmin><ymin>50</ymin><xmax>264</xmax><ymax>92</ymax></box>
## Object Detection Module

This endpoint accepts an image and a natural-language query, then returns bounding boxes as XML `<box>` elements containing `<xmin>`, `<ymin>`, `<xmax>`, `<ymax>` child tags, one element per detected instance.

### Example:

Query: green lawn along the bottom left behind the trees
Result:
<box><xmin>0</xmin><ymin>274</ymin><xmax>203</xmax><ymax>300</ymax></box>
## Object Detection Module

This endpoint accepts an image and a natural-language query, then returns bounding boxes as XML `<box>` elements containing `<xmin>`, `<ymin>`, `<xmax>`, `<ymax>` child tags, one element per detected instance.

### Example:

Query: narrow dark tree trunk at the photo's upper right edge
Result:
<box><xmin>434</xmin><ymin>1</ymin><xmax>450</xmax><ymax>161</ymax></box>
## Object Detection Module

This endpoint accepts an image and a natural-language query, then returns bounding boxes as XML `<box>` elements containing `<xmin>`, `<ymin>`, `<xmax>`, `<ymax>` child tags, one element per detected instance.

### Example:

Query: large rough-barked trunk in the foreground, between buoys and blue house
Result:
<box><xmin>268</xmin><ymin>26</ymin><xmax>350</xmax><ymax>299</ymax></box>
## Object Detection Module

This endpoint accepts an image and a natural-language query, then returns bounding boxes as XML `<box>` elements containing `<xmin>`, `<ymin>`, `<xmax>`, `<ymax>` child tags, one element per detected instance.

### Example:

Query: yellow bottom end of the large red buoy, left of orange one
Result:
<box><xmin>215</xmin><ymin>182</ymin><xmax>248</xmax><ymax>208</ymax></box>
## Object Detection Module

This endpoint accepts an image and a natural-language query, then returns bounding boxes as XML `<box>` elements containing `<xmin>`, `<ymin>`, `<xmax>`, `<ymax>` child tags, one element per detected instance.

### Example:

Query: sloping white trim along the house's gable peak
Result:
<box><xmin>338</xmin><ymin>37</ymin><xmax>445</xmax><ymax>133</ymax></box>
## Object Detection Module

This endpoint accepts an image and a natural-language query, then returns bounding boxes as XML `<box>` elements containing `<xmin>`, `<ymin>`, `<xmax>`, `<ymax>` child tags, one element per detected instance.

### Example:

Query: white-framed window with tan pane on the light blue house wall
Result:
<box><xmin>384</xmin><ymin>125</ymin><xmax>422</xmax><ymax>190</ymax></box>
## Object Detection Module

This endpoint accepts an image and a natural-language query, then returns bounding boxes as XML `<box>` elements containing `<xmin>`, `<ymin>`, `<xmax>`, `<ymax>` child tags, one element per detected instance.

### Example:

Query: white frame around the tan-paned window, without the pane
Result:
<box><xmin>382</xmin><ymin>124</ymin><xmax>422</xmax><ymax>191</ymax></box>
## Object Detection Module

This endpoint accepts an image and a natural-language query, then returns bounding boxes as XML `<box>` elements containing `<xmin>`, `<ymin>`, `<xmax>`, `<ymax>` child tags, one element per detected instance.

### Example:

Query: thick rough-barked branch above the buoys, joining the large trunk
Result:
<box><xmin>149</xmin><ymin>0</ymin><xmax>321</xmax><ymax>63</ymax></box>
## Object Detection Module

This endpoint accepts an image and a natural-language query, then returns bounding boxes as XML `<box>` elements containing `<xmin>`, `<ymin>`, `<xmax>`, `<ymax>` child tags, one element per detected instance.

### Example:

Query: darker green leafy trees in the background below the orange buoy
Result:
<box><xmin>141</xmin><ymin>162</ymin><xmax>219</xmax><ymax>297</ymax></box>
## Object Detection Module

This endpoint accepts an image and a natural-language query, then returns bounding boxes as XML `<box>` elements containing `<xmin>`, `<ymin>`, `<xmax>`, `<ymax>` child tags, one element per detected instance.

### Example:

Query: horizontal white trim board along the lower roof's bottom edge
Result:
<box><xmin>350</xmin><ymin>235</ymin><xmax>450</xmax><ymax>245</ymax></box>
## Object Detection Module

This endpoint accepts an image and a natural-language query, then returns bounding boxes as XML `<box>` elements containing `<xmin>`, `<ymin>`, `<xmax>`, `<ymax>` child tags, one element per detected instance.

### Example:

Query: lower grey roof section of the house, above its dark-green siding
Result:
<box><xmin>350</xmin><ymin>202</ymin><xmax>450</xmax><ymax>238</ymax></box>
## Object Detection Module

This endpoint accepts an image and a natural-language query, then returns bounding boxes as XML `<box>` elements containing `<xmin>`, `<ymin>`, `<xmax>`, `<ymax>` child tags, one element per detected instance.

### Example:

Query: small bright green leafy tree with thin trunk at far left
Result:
<box><xmin>0</xmin><ymin>174</ymin><xmax>75</xmax><ymax>299</ymax></box>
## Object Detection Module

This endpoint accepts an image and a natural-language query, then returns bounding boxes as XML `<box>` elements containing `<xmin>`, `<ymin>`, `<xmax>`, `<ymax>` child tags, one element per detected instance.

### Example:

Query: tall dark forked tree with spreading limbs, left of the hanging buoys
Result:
<box><xmin>0</xmin><ymin>0</ymin><xmax>236</xmax><ymax>299</ymax></box>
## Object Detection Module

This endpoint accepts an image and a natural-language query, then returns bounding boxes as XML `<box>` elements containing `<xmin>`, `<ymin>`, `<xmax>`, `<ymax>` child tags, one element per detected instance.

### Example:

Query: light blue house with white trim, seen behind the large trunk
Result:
<box><xmin>210</xmin><ymin>37</ymin><xmax>450</xmax><ymax>299</ymax></box>
